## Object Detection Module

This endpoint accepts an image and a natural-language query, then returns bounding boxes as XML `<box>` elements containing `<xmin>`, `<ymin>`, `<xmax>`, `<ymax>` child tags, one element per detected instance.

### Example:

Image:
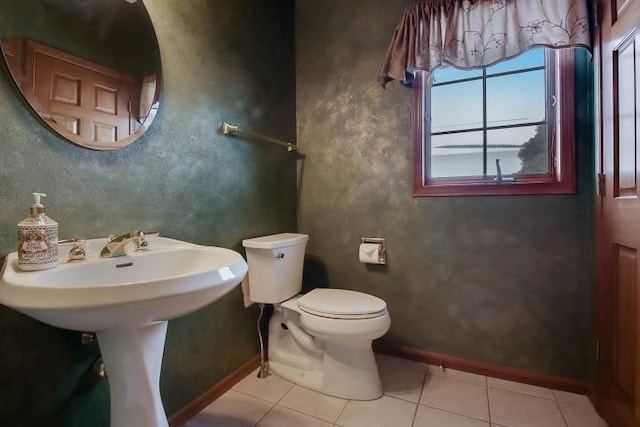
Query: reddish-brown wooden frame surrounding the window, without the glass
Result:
<box><xmin>411</xmin><ymin>49</ymin><xmax>576</xmax><ymax>197</ymax></box>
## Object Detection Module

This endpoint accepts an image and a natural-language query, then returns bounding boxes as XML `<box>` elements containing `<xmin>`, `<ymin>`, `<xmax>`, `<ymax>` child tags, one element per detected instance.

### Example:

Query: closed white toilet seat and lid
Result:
<box><xmin>297</xmin><ymin>288</ymin><xmax>387</xmax><ymax>320</ymax></box>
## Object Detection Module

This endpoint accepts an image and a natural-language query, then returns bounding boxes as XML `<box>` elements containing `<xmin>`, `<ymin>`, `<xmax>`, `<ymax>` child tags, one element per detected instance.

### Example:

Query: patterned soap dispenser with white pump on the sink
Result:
<box><xmin>18</xmin><ymin>193</ymin><xmax>58</xmax><ymax>271</ymax></box>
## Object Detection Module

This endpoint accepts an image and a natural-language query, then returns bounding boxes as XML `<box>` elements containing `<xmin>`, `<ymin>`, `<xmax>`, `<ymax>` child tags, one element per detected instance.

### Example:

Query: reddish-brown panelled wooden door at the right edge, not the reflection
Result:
<box><xmin>595</xmin><ymin>0</ymin><xmax>640</xmax><ymax>427</ymax></box>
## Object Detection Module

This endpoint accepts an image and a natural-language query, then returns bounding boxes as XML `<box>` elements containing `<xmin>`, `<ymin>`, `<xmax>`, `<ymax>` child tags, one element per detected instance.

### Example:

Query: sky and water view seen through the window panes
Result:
<box><xmin>430</xmin><ymin>48</ymin><xmax>546</xmax><ymax>178</ymax></box>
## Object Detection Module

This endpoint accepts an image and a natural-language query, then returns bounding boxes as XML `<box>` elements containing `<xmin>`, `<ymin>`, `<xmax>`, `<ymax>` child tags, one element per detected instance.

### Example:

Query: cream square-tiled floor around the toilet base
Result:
<box><xmin>185</xmin><ymin>355</ymin><xmax>607</xmax><ymax>427</ymax></box>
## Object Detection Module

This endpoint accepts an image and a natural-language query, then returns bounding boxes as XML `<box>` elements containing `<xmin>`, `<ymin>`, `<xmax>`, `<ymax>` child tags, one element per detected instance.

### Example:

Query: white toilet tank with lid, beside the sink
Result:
<box><xmin>242</xmin><ymin>233</ymin><xmax>309</xmax><ymax>304</ymax></box>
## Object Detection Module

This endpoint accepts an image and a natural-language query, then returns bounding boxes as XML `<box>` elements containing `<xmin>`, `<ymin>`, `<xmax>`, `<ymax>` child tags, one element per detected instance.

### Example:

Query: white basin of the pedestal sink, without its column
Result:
<box><xmin>0</xmin><ymin>237</ymin><xmax>247</xmax><ymax>331</ymax></box>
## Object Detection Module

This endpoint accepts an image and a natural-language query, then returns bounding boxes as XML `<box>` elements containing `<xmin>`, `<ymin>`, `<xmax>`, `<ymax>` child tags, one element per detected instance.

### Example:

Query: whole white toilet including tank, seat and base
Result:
<box><xmin>242</xmin><ymin>233</ymin><xmax>391</xmax><ymax>400</ymax></box>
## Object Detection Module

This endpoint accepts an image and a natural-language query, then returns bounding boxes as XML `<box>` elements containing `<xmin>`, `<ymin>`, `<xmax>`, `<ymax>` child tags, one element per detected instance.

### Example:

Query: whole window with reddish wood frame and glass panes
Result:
<box><xmin>413</xmin><ymin>47</ymin><xmax>575</xmax><ymax>196</ymax></box>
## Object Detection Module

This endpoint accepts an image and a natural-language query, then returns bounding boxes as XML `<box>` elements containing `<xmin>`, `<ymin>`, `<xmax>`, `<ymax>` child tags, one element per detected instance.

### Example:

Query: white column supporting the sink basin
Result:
<box><xmin>96</xmin><ymin>321</ymin><xmax>169</xmax><ymax>427</ymax></box>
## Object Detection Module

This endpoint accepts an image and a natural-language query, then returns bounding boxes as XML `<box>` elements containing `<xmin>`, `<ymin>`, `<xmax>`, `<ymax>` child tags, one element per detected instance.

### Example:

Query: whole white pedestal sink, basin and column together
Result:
<box><xmin>0</xmin><ymin>237</ymin><xmax>247</xmax><ymax>427</ymax></box>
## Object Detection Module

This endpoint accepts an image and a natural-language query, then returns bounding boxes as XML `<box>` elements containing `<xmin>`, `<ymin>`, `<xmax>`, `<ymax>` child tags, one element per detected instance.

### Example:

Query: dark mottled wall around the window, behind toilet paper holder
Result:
<box><xmin>296</xmin><ymin>0</ymin><xmax>593</xmax><ymax>380</ymax></box>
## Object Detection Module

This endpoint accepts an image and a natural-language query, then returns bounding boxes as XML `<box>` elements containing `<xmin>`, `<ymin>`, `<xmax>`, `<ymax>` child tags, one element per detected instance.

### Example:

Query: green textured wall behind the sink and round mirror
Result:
<box><xmin>0</xmin><ymin>0</ymin><xmax>296</xmax><ymax>427</ymax></box>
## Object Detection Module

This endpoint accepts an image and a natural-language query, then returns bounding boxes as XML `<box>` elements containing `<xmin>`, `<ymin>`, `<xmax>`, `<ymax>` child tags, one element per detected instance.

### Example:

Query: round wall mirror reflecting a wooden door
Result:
<box><xmin>0</xmin><ymin>0</ymin><xmax>161</xmax><ymax>150</ymax></box>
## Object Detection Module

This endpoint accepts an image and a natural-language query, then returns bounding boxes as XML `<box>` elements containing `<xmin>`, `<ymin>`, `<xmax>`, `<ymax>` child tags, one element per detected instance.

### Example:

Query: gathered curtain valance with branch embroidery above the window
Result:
<box><xmin>378</xmin><ymin>0</ymin><xmax>591</xmax><ymax>87</ymax></box>
